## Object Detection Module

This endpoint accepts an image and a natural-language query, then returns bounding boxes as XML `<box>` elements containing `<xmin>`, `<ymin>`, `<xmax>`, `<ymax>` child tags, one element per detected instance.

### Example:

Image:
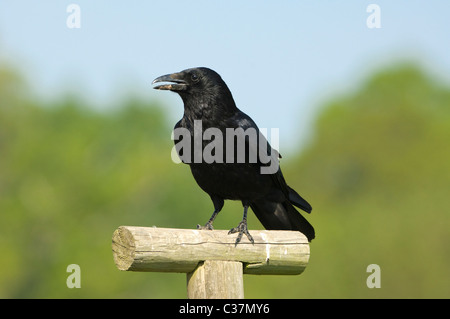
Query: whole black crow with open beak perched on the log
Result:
<box><xmin>152</xmin><ymin>67</ymin><xmax>315</xmax><ymax>246</ymax></box>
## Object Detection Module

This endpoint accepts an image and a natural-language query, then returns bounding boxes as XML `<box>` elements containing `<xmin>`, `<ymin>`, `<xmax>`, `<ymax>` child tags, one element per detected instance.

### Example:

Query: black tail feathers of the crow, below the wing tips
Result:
<box><xmin>250</xmin><ymin>200</ymin><xmax>315</xmax><ymax>241</ymax></box>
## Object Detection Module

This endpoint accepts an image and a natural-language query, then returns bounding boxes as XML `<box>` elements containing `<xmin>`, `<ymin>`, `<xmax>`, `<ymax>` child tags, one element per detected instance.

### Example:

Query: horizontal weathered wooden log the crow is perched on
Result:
<box><xmin>112</xmin><ymin>226</ymin><xmax>309</xmax><ymax>275</ymax></box>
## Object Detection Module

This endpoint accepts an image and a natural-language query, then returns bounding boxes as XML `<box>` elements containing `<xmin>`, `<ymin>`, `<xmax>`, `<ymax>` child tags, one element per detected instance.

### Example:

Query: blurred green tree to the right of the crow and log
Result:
<box><xmin>252</xmin><ymin>65</ymin><xmax>450</xmax><ymax>298</ymax></box>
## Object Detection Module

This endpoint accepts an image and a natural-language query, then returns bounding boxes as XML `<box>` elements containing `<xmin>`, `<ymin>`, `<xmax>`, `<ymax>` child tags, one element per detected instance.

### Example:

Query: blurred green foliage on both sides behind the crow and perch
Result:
<box><xmin>0</xmin><ymin>65</ymin><xmax>450</xmax><ymax>298</ymax></box>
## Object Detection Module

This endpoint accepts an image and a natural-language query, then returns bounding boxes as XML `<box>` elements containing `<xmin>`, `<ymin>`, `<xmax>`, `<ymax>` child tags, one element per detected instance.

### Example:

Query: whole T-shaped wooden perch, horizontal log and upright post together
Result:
<box><xmin>112</xmin><ymin>226</ymin><xmax>309</xmax><ymax>298</ymax></box>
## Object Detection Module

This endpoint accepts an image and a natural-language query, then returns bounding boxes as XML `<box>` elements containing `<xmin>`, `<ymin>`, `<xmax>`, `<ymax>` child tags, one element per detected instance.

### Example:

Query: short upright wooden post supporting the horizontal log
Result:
<box><xmin>187</xmin><ymin>260</ymin><xmax>244</xmax><ymax>299</ymax></box>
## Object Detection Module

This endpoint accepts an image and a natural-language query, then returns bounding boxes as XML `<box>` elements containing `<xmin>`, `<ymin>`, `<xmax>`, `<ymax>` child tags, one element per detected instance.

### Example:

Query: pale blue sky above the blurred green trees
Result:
<box><xmin>0</xmin><ymin>0</ymin><xmax>450</xmax><ymax>153</ymax></box>
